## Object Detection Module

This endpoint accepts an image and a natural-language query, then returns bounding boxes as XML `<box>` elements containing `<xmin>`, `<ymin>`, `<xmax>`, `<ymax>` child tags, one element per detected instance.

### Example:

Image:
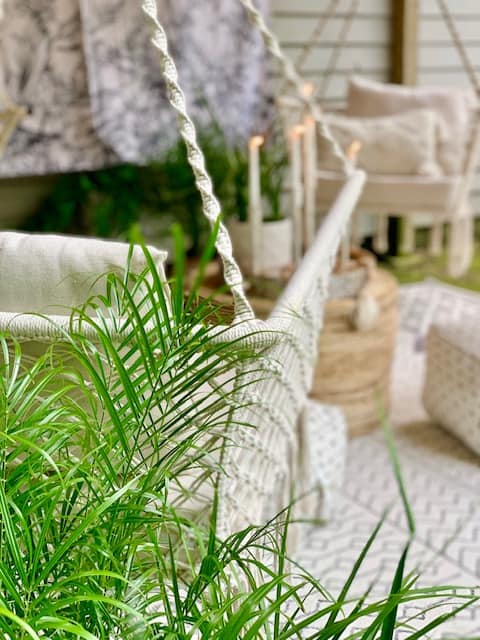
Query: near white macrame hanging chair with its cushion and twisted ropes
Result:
<box><xmin>0</xmin><ymin>0</ymin><xmax>365</xmax><ymax>538</ymax></box>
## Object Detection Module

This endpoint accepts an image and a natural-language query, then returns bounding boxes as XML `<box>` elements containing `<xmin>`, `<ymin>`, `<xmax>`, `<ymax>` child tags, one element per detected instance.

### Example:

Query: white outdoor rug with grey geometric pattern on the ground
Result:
<box><xmin>299</xmin><ymin>281</ymin><xmax>480</xmax><ymax>640</ymax></box>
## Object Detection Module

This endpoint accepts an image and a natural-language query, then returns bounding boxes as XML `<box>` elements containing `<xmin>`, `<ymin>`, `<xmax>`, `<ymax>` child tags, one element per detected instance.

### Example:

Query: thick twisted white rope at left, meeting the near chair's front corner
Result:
<box><xmin>142</xmin><ymin>0</ymin><xmax>255</xmax><ymax>321</ymax></box>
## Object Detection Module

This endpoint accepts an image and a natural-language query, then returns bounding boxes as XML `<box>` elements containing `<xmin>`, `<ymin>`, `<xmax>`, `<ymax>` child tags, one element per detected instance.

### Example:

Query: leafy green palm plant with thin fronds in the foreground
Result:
<box><xmin>0</xmin><ymin>228</ymin><xmax>476</xmax><ymax>640</ymax></box>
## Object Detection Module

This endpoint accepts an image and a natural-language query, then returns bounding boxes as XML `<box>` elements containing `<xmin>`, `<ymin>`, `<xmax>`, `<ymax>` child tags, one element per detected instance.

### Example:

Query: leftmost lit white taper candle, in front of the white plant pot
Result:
<box><xmin>248</xmin><ymin>136</ymin><xmax>264</xmax><ymax>276</ymax></box>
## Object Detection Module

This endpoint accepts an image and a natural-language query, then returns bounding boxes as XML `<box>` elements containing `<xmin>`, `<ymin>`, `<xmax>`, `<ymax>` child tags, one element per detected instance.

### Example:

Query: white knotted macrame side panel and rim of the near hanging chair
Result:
<box><xmin>219</xmin><ymin>172</ymin><xmax>365</xmax><ymax>535</ymax></box>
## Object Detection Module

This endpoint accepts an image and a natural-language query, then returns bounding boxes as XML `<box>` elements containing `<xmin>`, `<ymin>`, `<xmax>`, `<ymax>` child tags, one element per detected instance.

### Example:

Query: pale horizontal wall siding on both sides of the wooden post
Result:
<box><xmin>271</xmin><ymin>0</ymin><xmax>480</xmax><ymax>212</ymax></box>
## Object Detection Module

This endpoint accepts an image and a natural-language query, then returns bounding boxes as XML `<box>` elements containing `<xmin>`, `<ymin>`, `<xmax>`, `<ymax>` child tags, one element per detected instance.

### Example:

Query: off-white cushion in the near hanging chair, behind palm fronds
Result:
<box><xmin>0</xmin><ymin>232</ymin><xmax>167</xmax><ymax>315</ymax></box>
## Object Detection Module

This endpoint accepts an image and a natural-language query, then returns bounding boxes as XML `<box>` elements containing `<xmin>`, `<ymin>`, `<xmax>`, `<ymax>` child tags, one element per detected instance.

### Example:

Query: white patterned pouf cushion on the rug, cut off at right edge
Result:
<box><xmin>423</xmin><ymin>321</ymin><xmax>480</xmax><ymax>454</ymax></box>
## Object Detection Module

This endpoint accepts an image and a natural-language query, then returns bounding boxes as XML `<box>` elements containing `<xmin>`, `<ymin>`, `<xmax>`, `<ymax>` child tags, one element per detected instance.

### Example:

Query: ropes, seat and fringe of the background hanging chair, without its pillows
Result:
<box><xmin>281</xmin><ymin>0</ymin><xmax>480</xmax><ymax>277</ymax></box>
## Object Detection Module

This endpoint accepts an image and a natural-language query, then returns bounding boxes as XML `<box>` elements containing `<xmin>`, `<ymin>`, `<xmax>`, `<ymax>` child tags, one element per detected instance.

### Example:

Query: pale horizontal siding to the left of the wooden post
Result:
<box><xmin>271</xmin><ymin>0</ymin><xmax>390</xmax><ymax>104</ymax></box>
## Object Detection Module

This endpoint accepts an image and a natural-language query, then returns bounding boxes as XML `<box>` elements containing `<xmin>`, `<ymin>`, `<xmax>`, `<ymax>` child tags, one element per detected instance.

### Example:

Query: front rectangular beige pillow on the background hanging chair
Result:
<box><xmin>319</xmin><ymin>109</ymin><xmax>442</xmax><ymax>176</ymax></box>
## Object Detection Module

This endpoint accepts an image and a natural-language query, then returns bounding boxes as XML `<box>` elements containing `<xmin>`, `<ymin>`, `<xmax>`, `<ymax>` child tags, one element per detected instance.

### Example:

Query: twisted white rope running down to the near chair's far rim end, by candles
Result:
<box><xmin>239</xmin><ymin>0</ymin><xmax>354</xmax><ymax>175</ymax></box>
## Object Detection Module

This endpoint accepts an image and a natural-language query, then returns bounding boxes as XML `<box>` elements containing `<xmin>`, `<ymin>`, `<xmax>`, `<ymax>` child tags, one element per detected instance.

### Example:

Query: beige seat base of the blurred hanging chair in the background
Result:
<box><xmin>317</xmin><ymin>169</ymin><xmax>462</xmax><ymax>217</ymax></box>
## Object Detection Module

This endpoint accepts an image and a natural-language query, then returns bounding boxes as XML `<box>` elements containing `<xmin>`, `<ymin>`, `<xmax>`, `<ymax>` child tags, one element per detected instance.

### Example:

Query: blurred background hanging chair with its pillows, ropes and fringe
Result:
<box><xmin>279</xmin><ymin>0</ymin><xmax>480</xmax><ymax>277</ymax></box>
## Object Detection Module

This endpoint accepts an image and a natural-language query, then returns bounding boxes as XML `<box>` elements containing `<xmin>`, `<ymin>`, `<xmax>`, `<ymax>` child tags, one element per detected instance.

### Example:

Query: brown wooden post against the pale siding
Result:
<box><xmin>391</xmin><ymin>0</ymin><xmax>419</xmax><ymax>85</ymax></box>
